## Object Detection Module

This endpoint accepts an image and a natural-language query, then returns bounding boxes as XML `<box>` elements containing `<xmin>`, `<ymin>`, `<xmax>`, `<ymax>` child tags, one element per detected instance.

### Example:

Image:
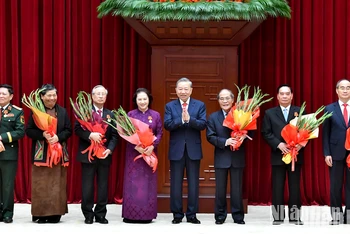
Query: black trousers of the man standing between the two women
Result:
<box><xmin>81</xmin><ymin>162</ymin><xmax>110</xmax><ymax>218</ymax></box>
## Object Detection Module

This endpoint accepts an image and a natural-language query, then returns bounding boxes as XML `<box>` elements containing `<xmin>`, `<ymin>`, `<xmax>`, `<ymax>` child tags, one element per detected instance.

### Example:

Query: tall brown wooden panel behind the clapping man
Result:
<box><xmin>152</xmin><ymin>46</ymin><xmax>243</xmax><ymax>212</ymax></box>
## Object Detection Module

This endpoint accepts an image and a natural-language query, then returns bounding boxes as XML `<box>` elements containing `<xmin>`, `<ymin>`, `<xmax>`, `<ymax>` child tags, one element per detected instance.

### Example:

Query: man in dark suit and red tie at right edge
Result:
<box><xmin>322</xmin><ymin>79</ymin><xmax>350</xmax><ymax>225</ymax></box>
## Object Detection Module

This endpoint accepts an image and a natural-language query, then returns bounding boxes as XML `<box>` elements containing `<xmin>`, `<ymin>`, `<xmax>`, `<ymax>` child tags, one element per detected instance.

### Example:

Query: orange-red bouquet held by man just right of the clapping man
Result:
<box><xmin>223</xmin><ymin>85</ymin><xmax>273</xmax><ymax>150</ymax></box>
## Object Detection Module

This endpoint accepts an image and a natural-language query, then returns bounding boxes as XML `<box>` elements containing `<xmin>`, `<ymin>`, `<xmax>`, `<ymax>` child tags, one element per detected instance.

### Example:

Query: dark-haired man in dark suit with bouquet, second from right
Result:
<box><xmin>261</xmin><ymin>84</ymin><xmax>304</xmax><ymax>225</ymax></box>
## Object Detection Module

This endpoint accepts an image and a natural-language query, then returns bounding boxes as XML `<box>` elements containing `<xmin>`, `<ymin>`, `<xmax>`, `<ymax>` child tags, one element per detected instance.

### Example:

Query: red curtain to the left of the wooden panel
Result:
<box><xmin>0</xmin><ymin>0</ymin><xmax>151</xmax><ymax>203</ymax></box>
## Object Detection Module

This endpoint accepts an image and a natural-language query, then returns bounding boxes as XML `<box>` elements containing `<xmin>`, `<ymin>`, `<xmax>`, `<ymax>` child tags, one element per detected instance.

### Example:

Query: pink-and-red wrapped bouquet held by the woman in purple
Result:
<box><xmin>108</xmin><ymin>107</ymin><xmax>158</xmax><ymax>172</ymax></box>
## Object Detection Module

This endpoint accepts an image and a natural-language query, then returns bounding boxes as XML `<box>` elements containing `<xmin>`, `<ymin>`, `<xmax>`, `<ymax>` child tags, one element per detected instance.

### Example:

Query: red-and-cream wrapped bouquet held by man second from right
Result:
<box><xmin>281</xmin><ymin>102</ymin><xmax>333</xmax><ymax>171</ymax></box>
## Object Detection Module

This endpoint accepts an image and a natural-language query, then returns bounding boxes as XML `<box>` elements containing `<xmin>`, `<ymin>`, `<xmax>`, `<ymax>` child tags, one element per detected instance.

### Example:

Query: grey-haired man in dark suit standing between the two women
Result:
<box><xmin>74</xmin><ymin>85</ymin><xmax>118</xmax><ymax>224</ymax></box>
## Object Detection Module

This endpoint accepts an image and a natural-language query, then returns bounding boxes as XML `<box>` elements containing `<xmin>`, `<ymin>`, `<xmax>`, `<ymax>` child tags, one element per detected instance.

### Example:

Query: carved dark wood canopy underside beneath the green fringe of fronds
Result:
<box><xmin>124</xmin><ymin>18</ymin><xmax>262</xmax><ymax>46</ymax></box>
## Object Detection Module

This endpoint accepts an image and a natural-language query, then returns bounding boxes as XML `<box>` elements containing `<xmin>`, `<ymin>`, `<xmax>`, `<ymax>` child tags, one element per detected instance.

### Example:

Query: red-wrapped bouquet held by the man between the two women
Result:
<box><xmin>69</xmin><ymin>91</ymin><xmax>108</xmax><ymax>162</ymax></box>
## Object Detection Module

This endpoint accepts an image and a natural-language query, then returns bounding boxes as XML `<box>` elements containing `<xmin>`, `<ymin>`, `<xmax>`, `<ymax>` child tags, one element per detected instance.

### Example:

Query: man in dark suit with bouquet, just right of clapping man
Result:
<box><xmin>207</xmin><ymin>89</ymin><xmax>245</xmax><ymax>224</ymax></box>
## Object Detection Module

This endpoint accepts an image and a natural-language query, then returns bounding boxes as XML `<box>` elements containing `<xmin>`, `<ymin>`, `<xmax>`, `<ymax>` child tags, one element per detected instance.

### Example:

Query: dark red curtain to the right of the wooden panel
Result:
<box><xmin>240</xmin><ymin>0</ymin><xmax>350</xmax><ymax>205</ymax></box>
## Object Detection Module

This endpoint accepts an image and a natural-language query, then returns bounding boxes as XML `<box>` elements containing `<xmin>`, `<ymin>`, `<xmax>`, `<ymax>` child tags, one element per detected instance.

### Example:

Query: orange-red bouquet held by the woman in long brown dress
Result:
<box><xmin>22</xmin><ymin>89</ymin><xmax>65</xmax><ymax>167</ymax></box>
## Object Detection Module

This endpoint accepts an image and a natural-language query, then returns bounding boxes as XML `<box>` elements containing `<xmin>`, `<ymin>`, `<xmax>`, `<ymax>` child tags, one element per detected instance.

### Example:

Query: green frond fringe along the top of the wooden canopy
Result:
<box><xmin>97</xmin><ymin>0</ymin><xmax>291</xmax><ymax>21</ymax></box>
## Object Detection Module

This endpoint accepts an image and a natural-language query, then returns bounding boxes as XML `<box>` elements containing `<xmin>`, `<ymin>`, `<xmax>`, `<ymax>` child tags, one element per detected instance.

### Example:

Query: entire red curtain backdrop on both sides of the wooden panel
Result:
<box><xmin>0</xmin><ymin>0</ymin><xmax>350</xmax><ymax>205</ymax></box>
